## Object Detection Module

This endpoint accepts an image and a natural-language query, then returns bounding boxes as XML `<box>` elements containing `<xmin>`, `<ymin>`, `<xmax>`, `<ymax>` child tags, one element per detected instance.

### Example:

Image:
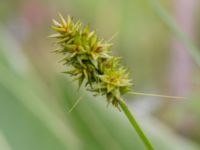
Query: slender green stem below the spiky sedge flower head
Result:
<box><xmin>120</xmin><ymin>99</ymin><xmax>154</xmax><ymax>150</ymax></box>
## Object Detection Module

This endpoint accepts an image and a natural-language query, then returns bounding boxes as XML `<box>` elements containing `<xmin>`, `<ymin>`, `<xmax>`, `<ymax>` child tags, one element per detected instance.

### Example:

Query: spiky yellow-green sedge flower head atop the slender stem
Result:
<box><xmin>50</xmin><ymin>15</ymin><xmax>132</xmax><ymax>107</ymax></box>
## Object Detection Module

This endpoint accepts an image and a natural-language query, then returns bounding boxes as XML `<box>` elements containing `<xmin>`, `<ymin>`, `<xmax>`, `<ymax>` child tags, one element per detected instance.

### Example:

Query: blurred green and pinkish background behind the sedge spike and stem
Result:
<box><xmin>0</xmin><ymin>0</ymin><xmax>200</xmax><ymax>150</ymax></box>
